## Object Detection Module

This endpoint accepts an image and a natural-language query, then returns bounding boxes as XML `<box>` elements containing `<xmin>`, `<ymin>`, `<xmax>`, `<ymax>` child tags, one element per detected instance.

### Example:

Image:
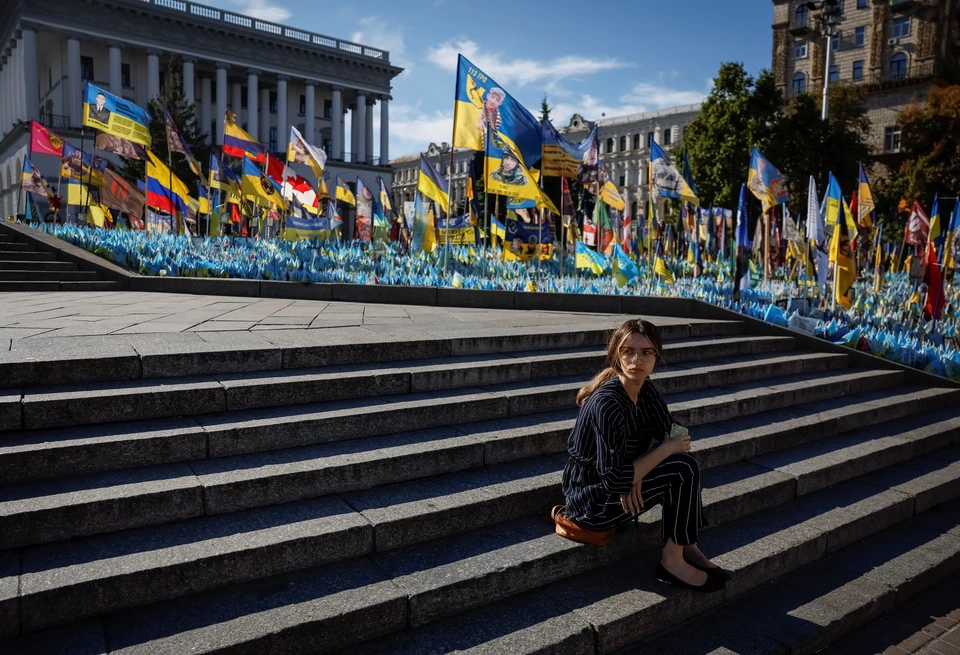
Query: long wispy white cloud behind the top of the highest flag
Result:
<box><xmin>427</xmin><ymin>39</ymin><xmax>631</xmax><ymax>86</ymax></box>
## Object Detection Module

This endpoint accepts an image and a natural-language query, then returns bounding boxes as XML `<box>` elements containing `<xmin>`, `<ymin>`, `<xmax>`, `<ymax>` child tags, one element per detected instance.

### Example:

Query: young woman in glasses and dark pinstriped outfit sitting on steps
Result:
<box><xmin>554</xmin><ymin>319</ymin><xmax>729</xmax><ymax>591</ymax></box>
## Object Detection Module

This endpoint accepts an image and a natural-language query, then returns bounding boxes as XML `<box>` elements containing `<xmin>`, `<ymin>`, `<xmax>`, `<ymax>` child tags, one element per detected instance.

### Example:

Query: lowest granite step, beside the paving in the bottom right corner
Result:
<box><xmin>618</xmin><ymin>502</ymin><xmax>960</xmax><ymax>655</ymax></box>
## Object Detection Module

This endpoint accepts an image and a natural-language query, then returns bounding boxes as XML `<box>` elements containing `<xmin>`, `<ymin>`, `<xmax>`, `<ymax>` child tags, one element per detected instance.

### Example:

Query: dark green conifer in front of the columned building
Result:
<box><xmin>121</xmin><ymin>57</ymin><xmax>210</xmax><ymax>194</ymax></box>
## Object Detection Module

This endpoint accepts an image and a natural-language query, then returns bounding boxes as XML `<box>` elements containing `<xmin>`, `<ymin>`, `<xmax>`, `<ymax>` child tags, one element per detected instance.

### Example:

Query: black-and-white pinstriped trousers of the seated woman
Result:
<box><xmin>589</xmin><ymin>453</ymin><xmax>707</xmax><ymax>546</ymax></box>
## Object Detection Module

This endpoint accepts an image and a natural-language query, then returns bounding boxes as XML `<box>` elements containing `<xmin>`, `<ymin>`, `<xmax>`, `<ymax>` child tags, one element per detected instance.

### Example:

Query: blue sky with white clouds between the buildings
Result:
<box><xmin>208</xmin><ymin>0</ymin><xmax>773</xmax><ymax>158</ymax></box>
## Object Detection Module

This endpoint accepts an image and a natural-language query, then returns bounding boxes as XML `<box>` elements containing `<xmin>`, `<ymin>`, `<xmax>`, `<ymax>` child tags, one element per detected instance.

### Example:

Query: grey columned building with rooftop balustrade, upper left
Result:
<box><xmin>0</xmin><ymin>0</ymin><xmax>402</xmax><ymax>216</ymax></box>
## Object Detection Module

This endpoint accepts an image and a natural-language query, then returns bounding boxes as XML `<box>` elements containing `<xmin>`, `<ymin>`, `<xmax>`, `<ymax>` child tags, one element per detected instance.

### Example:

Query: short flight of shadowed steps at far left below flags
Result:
<box><xmin>0</xmin><ymin>231</ymin><xmax>121</xmax><ymax>291</ymax></box>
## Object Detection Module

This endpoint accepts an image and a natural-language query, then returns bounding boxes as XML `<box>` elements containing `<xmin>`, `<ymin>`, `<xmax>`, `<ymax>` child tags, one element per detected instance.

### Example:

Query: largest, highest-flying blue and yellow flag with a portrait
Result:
<box><xmin>453</xmin><ymin>55</ymin><xmax>543</xmax><ymax>166</ymax></box>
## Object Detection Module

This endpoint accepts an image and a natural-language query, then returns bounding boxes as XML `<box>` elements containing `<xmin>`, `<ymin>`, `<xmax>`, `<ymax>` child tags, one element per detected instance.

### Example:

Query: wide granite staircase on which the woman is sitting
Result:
<box><xmin>0</xmin><ymin>315</ymin><xmax>960</xmax><ymax>654</ymax></box>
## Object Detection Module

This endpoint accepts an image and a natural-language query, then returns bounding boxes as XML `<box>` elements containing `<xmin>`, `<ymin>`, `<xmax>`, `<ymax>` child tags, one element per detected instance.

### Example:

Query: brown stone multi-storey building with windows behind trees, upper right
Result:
<box><xmin>773</xmin><ymin>0</ymin><xmax>960</xmax><ymax>160</ymax></box>
